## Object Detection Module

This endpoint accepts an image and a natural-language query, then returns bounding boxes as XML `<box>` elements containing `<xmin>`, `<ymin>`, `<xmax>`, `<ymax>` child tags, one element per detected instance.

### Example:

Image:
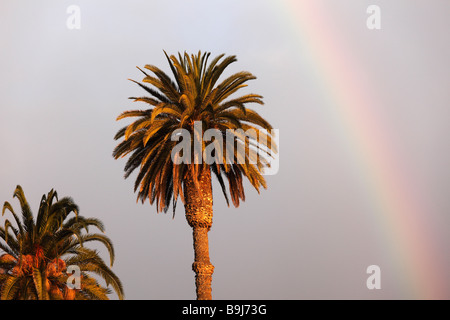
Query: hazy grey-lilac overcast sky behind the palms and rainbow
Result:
<box><xmin>0</xmin><ymin>0</ymin><xmax>450</xmax><ymax>299</ymax></box>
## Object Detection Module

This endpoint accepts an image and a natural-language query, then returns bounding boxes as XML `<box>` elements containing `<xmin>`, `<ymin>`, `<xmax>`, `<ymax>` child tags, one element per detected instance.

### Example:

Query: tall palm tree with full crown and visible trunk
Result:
<box><xmin>113</xmin><ymin>52</ymin><xmax>276</xmax><ymax>299</ymax></box>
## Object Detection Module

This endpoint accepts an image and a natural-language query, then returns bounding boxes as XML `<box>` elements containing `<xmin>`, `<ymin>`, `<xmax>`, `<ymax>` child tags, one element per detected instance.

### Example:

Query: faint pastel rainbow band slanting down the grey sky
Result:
<box><xmin>276</xmin><ymin>0</ymin><xmax>449</xmax><ymax>299</ymax></box>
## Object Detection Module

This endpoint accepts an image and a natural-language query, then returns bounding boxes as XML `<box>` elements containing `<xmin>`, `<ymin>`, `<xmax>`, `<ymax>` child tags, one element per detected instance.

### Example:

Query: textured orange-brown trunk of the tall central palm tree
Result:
<box><xmin>184</xmin><ymin>168</ymin><xmax>214</xmax><ymax>300</ymax></box>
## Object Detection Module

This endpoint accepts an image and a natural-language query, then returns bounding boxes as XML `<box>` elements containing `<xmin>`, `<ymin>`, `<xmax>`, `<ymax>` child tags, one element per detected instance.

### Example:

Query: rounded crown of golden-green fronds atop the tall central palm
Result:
<box><xmin>113</xmin><ymin>52</ymin><xmax>276</xmax><ymax>213</ymax></box>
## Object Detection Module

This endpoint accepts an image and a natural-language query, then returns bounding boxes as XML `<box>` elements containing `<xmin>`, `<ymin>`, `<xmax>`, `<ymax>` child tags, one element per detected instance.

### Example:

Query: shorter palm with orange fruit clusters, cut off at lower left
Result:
<box><xmin>0</xmin><ymin>186</ymin><xmax>123</xmax><ymax>300</ymax></box>
